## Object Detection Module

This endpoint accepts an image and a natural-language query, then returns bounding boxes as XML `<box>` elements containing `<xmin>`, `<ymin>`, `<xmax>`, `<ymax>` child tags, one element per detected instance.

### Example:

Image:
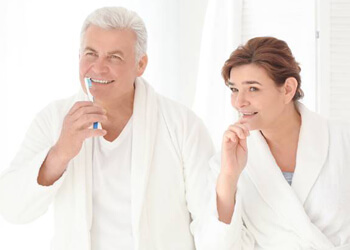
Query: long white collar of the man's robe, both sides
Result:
<box><xmin>72</xmin><ymin>78</ymin><xmax>158</xmax><ymax>249</ymax></box>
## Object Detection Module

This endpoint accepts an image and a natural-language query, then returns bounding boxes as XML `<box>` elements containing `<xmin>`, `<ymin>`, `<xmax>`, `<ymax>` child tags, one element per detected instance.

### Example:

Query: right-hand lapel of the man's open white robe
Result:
<box><xmin>131</xmin><ymin>78</ymin><xmax>158</xmax><ymax>249</ymax></box>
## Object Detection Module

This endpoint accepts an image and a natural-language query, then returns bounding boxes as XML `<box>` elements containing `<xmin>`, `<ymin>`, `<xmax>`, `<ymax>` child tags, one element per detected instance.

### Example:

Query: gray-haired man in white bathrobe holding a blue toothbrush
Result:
<box><xmin>0</xmin><ymin>8</ymin><xmax>213</xmax><ymax>250</ymax></box>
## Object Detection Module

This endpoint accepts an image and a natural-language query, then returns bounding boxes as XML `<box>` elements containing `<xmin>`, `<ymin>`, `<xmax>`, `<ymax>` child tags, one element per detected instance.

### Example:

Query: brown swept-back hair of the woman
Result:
<box><xmin>221</xmin><ymin>37</ymin><xmax>304</xmax><ymax>101</ymax></box>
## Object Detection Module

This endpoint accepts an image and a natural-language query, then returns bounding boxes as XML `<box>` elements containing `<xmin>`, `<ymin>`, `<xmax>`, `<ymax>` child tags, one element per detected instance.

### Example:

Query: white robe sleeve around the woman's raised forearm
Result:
<box><xmin>191</xmin><ymin>154</ymin><xmax>255</xmax><ymax>250</ymax></box>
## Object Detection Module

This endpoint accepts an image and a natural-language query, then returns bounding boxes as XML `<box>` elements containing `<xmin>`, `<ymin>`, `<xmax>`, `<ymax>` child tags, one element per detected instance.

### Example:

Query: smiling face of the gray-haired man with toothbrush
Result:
<box><xmin>79</xmin><ymin>25</ymin><xmax>147</xmax><ymax>102</ymax></box>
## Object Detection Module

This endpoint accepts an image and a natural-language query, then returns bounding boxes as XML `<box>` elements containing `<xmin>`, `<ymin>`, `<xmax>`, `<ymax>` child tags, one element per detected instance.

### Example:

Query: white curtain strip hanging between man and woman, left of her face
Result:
<box><xmin>193</xmin><ymin>0</ymin><xmax>242</xmax><ymax>150</ymax></box>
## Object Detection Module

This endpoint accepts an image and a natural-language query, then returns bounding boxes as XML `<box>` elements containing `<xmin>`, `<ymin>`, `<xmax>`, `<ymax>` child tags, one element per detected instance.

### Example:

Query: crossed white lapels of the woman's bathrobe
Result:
<box><xmin>246</xmin><ymin>103</ymin><xmax>334</xmax><ymax>249</ymax></box>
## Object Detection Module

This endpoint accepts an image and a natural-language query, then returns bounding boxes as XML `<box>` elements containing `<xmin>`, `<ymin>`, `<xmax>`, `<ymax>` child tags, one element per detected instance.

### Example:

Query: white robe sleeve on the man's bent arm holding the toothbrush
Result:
<box><xmin>0</xmin><ymin>106</ymin><xmax>65</xmax><ymax>224</ymax></box>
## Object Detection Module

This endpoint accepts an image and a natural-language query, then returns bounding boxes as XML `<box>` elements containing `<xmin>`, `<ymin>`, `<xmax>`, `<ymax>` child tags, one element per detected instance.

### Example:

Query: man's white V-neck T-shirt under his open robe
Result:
<box><xmin>91</xmin><ymin>118</ymin><xmax>133</xmax><ymax>250</ymax></box>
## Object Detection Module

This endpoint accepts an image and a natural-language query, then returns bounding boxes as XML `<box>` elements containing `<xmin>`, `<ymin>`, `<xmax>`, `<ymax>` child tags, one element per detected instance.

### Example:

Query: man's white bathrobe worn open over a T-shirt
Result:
<box><xmin>0</xmin><ymin>78</ymin><xmax>213</xmax><ymax>250</ymax></box>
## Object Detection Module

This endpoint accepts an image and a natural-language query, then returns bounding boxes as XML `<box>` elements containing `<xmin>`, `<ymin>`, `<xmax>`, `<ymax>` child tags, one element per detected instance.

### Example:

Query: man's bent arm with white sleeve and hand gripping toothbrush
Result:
<box><xmin>0</xmin><ymin>99</ymin><xmax>106</xmax><ymax>223</ymax></box>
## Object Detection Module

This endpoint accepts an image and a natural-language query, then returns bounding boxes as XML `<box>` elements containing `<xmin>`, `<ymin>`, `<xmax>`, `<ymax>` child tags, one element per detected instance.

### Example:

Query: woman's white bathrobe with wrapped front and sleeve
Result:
<box><xmin>196</xmin><ymin>104</ymin><xmax>350</xmax><ymax>250</ymax></box>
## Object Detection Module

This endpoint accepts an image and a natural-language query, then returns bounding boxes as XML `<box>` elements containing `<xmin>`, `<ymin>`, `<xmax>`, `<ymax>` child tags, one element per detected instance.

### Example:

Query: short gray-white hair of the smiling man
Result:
<box><xmin>80</xmin><ymin>7</ymin><xmax>147</xmax><ymax>62</ymax></box>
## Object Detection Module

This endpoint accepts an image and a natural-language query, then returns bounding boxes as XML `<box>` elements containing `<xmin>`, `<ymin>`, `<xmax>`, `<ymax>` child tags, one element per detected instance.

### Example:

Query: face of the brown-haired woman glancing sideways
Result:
<box><xmin>229</xmin><ymin>64</ymin><xmax>286</xmax><ymax>130</ymax></box>
